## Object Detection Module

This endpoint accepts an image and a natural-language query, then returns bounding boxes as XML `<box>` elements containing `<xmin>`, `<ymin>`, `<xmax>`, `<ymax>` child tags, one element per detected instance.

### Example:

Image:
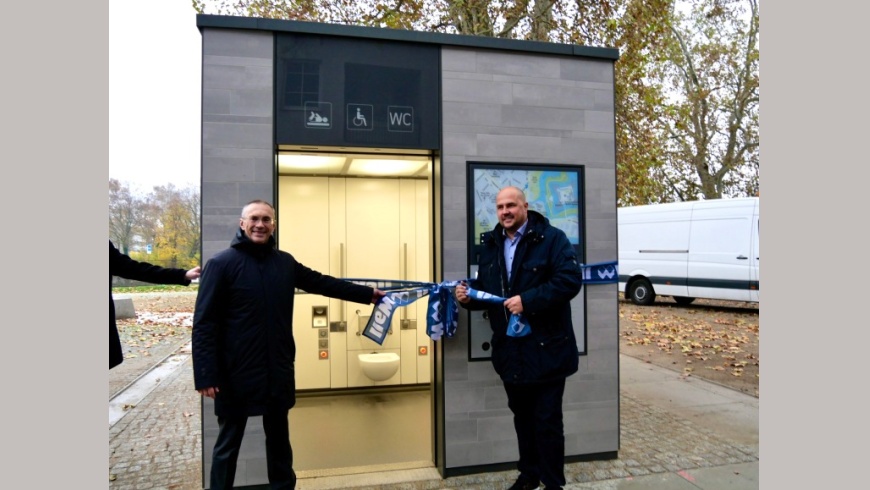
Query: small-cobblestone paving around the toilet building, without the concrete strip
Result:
<box><xmin>109</xmin><ymin>348</ymin><xmax>759</xmax><ymax>490</ymax></box>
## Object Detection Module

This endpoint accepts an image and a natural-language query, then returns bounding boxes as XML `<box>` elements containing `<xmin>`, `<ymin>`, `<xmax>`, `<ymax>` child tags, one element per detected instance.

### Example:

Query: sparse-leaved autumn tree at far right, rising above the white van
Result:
<box><xmin>657</xmin><ymin>0</ymin><xmax>759</xmax><ymax>200</ymax></box>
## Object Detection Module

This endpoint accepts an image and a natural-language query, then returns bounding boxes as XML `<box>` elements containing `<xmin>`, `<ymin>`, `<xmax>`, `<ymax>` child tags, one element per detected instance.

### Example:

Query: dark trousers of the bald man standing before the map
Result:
<box><xmin>504</xmin><ymin>379</ymin><xmax>565</xmax><ymax>487</ymax></box>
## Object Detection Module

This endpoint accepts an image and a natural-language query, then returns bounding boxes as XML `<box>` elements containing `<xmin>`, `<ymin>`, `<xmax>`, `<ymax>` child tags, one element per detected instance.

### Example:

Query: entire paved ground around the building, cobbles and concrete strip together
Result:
<box><xmin>109</xmin><ymin>355</ymin><xmax>759</xmax><ymax>490</ymax></box>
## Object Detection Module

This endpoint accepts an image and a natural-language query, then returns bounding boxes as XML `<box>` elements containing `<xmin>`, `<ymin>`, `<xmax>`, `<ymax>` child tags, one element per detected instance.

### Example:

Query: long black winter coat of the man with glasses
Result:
<box><xmin>192</xmin><ymin>229</ymin><xmax>374</xmax><ymax>417</ymax></box>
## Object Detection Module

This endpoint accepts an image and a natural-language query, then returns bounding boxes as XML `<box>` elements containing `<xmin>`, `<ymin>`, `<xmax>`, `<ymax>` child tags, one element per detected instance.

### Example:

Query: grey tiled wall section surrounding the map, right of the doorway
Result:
<box><xmin>442</xmin><ymin>47</ymin><xmax>619</xmax><ymax>468</ymax></box>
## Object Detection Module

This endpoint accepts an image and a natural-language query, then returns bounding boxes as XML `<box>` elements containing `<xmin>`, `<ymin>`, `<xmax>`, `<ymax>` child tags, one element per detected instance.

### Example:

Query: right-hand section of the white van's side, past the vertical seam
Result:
<box><xmin>688</xmin><ymin>200</ymin><xmax>754</xmax><ymax>301</ymax></box>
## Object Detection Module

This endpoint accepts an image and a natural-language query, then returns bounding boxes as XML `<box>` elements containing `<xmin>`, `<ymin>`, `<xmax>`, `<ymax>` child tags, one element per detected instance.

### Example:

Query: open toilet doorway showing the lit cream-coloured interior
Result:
<box><xmin>276</xmin><ymin>146</ymin><xmax>434</xmax><ymax>478</ymax></box>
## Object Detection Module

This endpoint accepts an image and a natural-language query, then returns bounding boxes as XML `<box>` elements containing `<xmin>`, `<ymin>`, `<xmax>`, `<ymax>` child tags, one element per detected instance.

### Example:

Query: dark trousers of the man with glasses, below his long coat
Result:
<box><xmin>209</xmin><ymin>410</ymin><xmax>296</xmax><ymax>490</ymax></box>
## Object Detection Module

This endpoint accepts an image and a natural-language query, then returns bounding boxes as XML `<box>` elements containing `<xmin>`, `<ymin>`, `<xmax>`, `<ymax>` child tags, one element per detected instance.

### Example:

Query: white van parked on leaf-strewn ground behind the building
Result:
<box><xmin>617</xmin><ymin>197</ymin><xmax>759</xmax><ymax>305</ymax></box>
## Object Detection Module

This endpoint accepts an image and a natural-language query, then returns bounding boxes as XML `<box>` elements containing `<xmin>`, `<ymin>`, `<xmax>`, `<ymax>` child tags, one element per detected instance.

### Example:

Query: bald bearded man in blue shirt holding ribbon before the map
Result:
<box><xmin>455</xmin><ymin>186</ymin><xmax>583</xmax><ymax>490</ymax></box>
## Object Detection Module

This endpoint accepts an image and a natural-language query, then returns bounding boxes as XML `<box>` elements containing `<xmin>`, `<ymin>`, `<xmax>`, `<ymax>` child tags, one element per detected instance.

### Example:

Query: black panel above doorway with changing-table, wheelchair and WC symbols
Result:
<box><xmin>275</xmin><ymin>33</ymin><xmax>441</xmax><ymax>149</ymax></box>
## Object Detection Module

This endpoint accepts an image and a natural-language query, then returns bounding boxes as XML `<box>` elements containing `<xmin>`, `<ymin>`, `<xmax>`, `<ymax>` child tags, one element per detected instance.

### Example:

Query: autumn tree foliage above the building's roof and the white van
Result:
<box><xmin>193</xmin><ymin>0</ymin><xmax>759</xmax><ymax>205</ymax></box>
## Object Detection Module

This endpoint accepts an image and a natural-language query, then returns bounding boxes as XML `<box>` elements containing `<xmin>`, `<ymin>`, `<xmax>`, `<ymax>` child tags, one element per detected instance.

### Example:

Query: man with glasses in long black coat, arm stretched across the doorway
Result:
<box><xmin>192</xmin><ymin>200</ymin><xmax>384</xmax><ymax>490</ymax></box>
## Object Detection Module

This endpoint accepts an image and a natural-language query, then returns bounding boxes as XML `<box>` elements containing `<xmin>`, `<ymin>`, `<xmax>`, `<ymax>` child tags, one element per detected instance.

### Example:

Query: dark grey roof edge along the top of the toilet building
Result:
<box><xmin>196</xmin><ymin>14</ymin><xmax>619</xmax><ymax>61</ymax></box>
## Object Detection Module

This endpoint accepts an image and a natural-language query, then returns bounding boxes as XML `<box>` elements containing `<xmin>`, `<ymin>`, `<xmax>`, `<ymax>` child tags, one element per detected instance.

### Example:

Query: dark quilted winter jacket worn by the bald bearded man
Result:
<box><xmin>462</xmin><ymin>211</ymin><xmax>583</xmax><ymax>384</ymax></box>
